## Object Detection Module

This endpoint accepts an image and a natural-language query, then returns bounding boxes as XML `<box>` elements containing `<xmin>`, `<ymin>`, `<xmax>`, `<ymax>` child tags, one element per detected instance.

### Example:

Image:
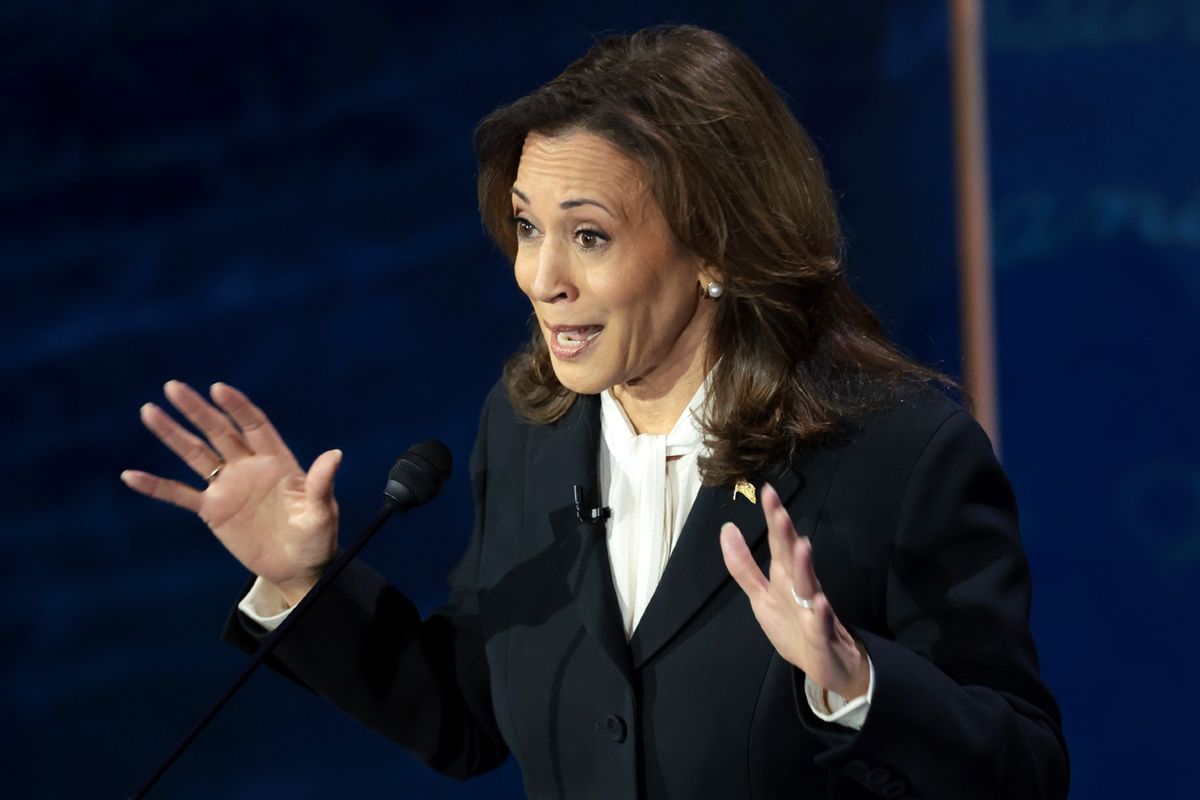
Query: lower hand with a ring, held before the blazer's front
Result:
<box><xmin>721</xmin><ymin>485</ymin><xmax>870</xmax><ymax>700</ymax></box>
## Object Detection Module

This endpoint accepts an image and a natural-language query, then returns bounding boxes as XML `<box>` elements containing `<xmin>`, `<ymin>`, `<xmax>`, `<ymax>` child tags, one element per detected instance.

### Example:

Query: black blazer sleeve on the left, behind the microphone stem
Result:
<box><xmin>223</xmin><ymin>383</ymin><xmax>508</xmax><ymax>777</ymax></box>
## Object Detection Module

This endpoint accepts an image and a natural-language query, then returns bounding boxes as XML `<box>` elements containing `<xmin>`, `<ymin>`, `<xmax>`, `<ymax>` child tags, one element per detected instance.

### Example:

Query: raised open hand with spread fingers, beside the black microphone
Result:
<box><xmin>121</xmin><ymin>380</ymin><xmax>342</xmax><ymax>606</ymax></box>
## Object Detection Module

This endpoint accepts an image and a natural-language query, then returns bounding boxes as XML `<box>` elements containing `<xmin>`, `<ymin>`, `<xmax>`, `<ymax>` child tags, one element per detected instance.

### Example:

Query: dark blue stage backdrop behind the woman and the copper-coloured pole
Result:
<box><xmin>0</xmin><ymin>0</ymin><xmax>1200</xmax><ymax>800</ymax></box>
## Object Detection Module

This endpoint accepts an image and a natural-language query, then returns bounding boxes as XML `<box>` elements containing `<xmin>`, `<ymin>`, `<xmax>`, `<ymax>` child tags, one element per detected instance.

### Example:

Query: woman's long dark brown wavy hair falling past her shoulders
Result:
<box><xmin>475</xmin><ymin>26</ymin><xmax>949</xmax><ymax>485</ymax></box>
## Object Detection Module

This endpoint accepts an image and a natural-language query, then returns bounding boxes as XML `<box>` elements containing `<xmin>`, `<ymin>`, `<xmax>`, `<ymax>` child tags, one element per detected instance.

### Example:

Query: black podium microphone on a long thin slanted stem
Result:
<box><xmin>130</xmin><ymin>439</ymin><xmax>454</xmax><ymax>800</ymax></box>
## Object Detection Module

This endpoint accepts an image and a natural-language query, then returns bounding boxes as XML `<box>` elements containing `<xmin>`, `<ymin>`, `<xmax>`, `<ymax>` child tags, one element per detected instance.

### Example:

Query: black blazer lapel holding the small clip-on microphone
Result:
<box><xmin>527</xmin><ymin>395</ymin><xmax>632</xmax><ymax>682</ymax></box>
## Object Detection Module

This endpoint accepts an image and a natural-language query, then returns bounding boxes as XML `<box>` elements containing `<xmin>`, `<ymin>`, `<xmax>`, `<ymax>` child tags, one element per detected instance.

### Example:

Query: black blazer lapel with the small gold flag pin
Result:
<box><xmin>629</xmin><ymin>467</ymin><xmax>804</xmax><ymax>669</ymax></box>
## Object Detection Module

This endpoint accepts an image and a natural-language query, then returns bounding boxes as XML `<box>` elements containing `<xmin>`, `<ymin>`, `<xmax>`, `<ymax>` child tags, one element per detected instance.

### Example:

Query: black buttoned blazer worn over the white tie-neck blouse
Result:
<box><xmin>227</xmin><ymin>386</ymin><xmax>1067</xmax><ymax>800</ymax></box>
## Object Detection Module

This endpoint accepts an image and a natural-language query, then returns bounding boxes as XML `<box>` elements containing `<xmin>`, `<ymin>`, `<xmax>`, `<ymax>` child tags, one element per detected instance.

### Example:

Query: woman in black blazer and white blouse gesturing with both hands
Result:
<box><xmin>124</xmin><ymin>28</ymin><xmax>1067</xmax><ymax>799</ymax></box>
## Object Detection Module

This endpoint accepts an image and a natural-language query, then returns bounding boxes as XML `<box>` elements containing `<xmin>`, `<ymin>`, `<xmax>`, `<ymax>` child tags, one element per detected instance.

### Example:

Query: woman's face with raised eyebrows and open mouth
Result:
<box><xmin>512</xmin><ymin>132</ymin><xmax>714</xmax><ymax>395</ymax></box>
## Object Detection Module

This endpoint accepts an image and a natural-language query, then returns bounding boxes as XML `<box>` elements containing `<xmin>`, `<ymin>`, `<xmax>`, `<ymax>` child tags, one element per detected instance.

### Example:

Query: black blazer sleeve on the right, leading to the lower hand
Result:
<box><xmin>797</xmin><ymin>410</ymin><xmax>1068</xmax><ymax>800</ymax></box>
